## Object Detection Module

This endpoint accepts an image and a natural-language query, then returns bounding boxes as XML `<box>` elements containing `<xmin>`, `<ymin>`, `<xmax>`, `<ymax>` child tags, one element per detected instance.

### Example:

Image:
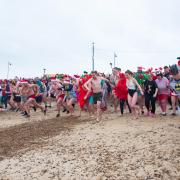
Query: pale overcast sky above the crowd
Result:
<box><xmin>0</xmin><ymin>0</ymin><xmax>180</xmax><ymax>78</ymax></box>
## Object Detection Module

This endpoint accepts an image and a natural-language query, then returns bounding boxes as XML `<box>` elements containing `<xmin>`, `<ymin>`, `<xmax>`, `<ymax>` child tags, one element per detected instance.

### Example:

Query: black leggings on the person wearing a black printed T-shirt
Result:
<box><xmin>145</xmin><ymin>94</ymin><xmax>156</xmax><ymax>114</ymax></box>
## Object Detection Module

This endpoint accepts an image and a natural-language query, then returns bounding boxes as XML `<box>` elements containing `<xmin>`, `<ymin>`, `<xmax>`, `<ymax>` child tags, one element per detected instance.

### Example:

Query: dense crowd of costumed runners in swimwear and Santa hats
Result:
<box><xmin>0</xmin><ymin>58</ymin><xmax>180</xmax><ymax>121</ymax></box>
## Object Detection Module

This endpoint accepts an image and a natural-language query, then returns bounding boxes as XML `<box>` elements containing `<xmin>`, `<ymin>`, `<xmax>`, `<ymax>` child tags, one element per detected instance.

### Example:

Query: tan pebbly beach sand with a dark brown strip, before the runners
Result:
<box><xmin>0</xmin><ymin>106</ymin><xmax>180</xmax><ymax>180</ymax></box>
